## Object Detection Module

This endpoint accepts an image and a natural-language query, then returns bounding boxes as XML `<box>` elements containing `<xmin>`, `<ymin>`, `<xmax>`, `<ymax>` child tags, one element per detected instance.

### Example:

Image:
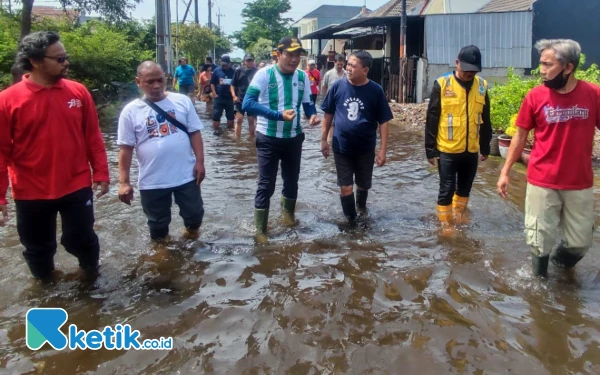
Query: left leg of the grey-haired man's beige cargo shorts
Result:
<box><xmin>525</xmin><ymin>184</ymin><xmax>563</xmax><ymax>257</ymax></box>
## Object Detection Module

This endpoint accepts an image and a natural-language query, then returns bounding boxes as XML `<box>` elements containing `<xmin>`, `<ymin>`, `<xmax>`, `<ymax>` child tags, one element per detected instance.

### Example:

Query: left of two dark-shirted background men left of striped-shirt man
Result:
<box><xmin>210</xmin><ymin>55</ymin><xmax>235</xmax><ymax>135</ymax></box>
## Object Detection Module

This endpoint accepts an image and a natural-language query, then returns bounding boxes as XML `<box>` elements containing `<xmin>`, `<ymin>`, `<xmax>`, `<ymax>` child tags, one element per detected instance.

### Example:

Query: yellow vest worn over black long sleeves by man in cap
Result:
<box><xmin>437</xmin><ymin>72</ymin><xmax>487</xmax><ymax>154</ymax></box>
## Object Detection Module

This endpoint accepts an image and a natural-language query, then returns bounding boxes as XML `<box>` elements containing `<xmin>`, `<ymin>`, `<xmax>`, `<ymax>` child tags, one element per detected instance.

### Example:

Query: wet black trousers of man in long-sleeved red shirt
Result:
<box><xmin>15</xmin><ymin>188</ymin><xmax>100</xmax><ymax>279</ymax></box>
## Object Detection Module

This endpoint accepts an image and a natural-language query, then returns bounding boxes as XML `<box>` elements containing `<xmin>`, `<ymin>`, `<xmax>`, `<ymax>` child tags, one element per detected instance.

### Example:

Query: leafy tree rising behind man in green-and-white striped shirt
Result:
<box><xmin>233</xmin><ymin>0</ymin><xmax>292</xmax><ymax>50</ymax></box>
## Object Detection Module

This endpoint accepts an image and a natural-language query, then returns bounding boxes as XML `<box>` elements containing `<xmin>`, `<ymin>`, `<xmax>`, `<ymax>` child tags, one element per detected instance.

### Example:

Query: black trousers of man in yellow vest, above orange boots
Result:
<box><xmin>438</xmin><ymin>152</ymin><xmax>479</xmax><ymax>206</ymax></box>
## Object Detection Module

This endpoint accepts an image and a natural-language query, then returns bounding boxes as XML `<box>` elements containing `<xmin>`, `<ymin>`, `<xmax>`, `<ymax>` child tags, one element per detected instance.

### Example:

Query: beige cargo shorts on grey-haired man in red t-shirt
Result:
<box><xmin>525</xmin><ymin>184</ymin><xmax>594</xmax><ymax>256</ymax></box>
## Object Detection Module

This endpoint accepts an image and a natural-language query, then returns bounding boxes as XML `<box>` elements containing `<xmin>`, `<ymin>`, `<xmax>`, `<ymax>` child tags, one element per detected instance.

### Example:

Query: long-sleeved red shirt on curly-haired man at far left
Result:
<box><xmin>0</xmin><ymin>75</ymin><xmax>109</xmax><ymax>204</ymax></box>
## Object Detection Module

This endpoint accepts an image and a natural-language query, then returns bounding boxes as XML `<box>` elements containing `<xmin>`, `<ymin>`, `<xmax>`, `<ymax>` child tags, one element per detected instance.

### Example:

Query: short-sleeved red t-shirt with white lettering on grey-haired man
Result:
<box><xmin>517</xmin><ymin>81</ymin><xmax>600</xmax><ymax>190</ymax></box>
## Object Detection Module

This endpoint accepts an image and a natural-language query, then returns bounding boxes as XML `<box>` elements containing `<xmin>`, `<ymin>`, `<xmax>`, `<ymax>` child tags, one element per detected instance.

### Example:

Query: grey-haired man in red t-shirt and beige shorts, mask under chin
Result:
<box><xmin>498</xmin><ymin>39</ymin><xmax>600</xmax><ymax>276</ymax></box>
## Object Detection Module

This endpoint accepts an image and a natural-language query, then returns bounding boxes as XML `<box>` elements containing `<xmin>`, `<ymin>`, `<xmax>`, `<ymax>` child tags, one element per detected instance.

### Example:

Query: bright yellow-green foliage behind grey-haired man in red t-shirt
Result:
<box><xmin>489</xmin><ymin>54</ymin><xmax>600</xmax><ymax>132</ymax></box>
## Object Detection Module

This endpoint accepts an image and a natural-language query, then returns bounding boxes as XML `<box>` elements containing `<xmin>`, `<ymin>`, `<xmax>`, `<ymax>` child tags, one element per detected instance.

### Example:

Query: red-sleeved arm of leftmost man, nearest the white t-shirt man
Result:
<box><xmin>83</xmin><ymin>89</ymin><xmax>110</xmax><ymax>191</ymax></box>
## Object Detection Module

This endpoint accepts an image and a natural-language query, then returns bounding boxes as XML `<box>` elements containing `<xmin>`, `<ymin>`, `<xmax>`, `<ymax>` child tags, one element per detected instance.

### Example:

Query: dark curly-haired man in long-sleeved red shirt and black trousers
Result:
<box><xmin>0</xmin><ymin>31</ymin><xmax>109</xmax><ymax>279</ymax></box>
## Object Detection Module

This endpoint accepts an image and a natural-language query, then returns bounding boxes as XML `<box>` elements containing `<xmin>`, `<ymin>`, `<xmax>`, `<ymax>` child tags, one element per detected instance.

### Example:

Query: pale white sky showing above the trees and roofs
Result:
<box><xmin>24</xmin><ymin>0</ymin><xmax>387</xmax><ymax>57</ymax></box>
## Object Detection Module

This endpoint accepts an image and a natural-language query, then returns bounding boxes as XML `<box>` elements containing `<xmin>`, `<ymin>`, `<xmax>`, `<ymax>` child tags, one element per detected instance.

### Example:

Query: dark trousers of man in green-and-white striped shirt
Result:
<box><xmin>254</xmin><ymin>132</ymin><xmax>304</xmax><ymax>209</ymax></box>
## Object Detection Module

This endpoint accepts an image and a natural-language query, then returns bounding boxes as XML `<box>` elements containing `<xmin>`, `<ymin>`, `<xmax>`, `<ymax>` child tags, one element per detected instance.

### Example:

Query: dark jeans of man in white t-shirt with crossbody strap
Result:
<box><xmin>140</xmin><ymin>181</ymin><xmax>204</xmax><ymax>240</ymax></box>
